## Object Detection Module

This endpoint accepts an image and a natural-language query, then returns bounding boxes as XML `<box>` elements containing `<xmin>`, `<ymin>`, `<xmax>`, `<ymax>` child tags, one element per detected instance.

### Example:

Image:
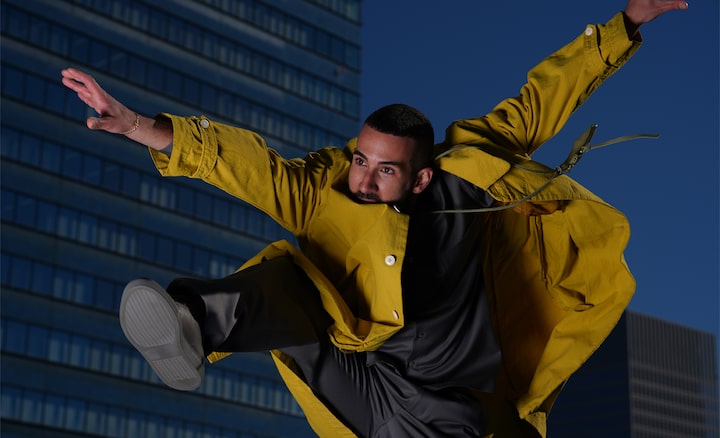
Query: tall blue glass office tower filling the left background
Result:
<box><xmin>0</xmin><ymin>0</ymin><xmax>361</xmax><ymax>438</ymax></box>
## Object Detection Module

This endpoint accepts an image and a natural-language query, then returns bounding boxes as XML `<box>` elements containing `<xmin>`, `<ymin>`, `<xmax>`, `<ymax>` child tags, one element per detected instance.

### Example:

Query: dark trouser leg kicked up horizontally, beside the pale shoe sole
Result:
<box><xmin>167</xmin><ymin>257</ymin><xmax>331</xmax><ymax>353</ymax></box>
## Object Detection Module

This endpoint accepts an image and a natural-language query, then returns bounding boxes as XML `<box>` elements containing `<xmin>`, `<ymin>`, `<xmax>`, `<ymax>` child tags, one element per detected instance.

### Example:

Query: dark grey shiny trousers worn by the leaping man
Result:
<box><xmin>168</xmin><ymin>257</ymin><xmax>486</xmax><ymax>437</ymax></box>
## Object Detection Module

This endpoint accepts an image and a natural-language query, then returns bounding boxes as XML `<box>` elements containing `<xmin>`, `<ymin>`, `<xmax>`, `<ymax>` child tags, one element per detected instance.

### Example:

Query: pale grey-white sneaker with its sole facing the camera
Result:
<box><xmin>120</xmin><ymin>279</ymin><xmax>205</xmax><ymax>391</ymax></box>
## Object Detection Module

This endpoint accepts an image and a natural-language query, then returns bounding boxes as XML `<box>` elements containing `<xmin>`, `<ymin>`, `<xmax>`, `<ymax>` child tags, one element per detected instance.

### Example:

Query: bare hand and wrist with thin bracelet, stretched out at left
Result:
<box><xmin>62</xmin><ymin>68</ymin><xmax>173</xmax><ymax>151</ymax></box>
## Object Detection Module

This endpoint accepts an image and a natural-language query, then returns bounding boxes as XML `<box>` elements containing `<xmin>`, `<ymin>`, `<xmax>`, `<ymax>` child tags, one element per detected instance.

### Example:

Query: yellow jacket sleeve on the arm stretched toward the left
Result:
<box><xmin>150</xmin><ymin>114</ymin><xmax>343</xmax><ymax>234</ymax></box>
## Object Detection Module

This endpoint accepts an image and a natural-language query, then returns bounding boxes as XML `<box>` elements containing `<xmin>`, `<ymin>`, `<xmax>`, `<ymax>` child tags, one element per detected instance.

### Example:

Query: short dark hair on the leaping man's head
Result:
<box><xmin>365</xmin><ymin>103</ymin><xmax>435</xmax><ymax>170</ymax></box>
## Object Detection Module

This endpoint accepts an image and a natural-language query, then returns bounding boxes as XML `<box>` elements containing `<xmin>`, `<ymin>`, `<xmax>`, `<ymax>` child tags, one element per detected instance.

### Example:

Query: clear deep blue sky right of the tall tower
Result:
<box><xmin>362</xmin><ymin>0</ymin><xmax>720</xmax><ymax>335</ymax></box>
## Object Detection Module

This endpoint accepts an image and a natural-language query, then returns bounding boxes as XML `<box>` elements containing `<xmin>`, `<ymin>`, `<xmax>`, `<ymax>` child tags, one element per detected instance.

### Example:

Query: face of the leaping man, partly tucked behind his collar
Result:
<box><xmin>348</xmin><ymin>125</ymin><xmax>432</xmax><ymax>203</ymax></box>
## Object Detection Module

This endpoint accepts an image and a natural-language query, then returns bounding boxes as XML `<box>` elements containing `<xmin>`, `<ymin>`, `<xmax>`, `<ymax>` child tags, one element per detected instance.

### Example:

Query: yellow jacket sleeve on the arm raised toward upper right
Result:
<box><xmin>445</xmin><ymin>13</ymin><xmax>641</xmax><ymax>155</ymax></box>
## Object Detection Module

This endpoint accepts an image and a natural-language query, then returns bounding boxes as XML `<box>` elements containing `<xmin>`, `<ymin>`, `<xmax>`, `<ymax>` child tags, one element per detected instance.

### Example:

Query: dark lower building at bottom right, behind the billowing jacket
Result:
<box><xmin>548</xmin><ymin>312</ymin><xmax>720</xmax><ymax>438</ymax></box>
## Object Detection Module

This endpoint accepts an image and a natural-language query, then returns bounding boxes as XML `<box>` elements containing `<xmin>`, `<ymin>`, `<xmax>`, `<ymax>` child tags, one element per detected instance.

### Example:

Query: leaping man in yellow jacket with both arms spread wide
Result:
<box><xmin>63</xmin><ymin>0</ymin><xmax>687</xmax><ymax>436</ymax></box>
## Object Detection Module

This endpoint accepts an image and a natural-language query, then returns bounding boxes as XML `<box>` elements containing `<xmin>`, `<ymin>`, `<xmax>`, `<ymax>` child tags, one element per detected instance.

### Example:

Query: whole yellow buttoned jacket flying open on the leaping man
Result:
<box><xmin>151</xmin><ymin>14</ymin><xmax>639</xmax><ymax>437</ymax></box>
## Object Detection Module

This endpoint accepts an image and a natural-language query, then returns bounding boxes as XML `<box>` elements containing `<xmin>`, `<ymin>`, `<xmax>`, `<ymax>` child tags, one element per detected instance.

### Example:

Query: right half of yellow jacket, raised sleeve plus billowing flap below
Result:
<box><xmin>440</xmin><ymin>14</ymin><xmax>639</xmax><ymax>420</ymax></box>
